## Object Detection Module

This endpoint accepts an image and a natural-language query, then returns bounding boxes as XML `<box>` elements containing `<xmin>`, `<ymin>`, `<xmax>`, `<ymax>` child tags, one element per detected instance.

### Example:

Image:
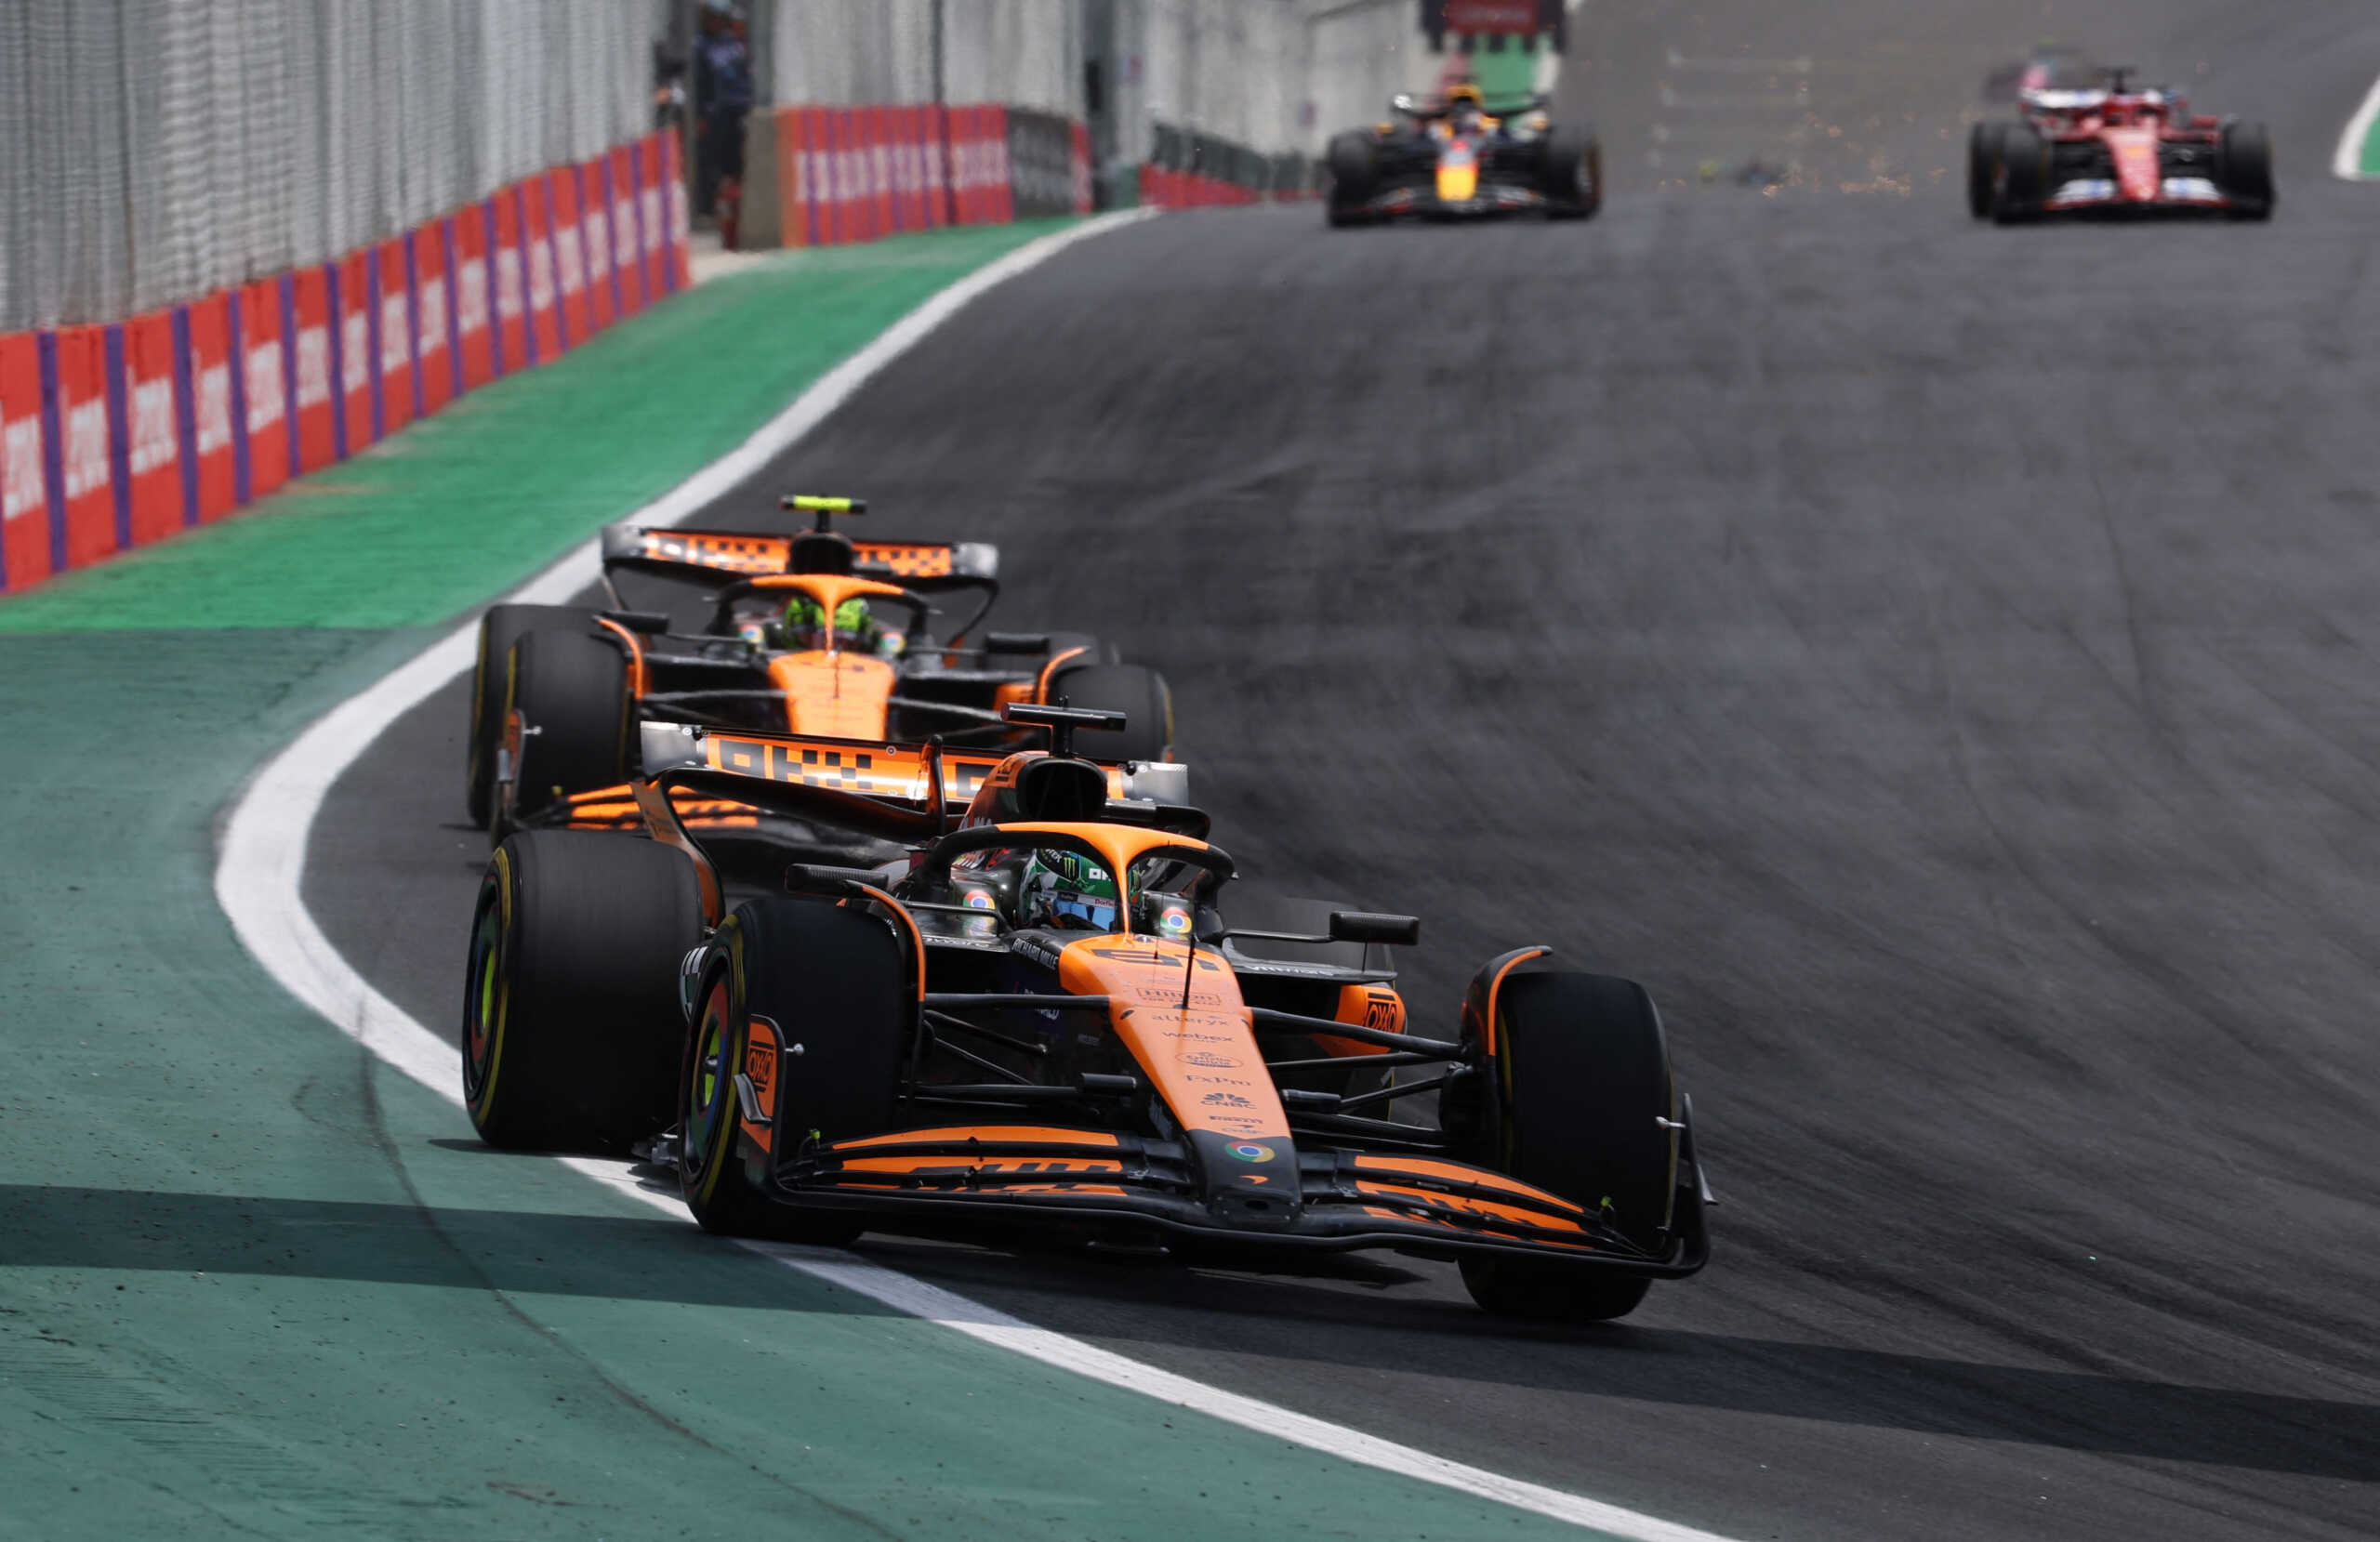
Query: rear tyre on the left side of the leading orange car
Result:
<box><xmin>462</xmin><ymin>831</ymin><xmax>702</xmax><ymax>1152</ymax></box>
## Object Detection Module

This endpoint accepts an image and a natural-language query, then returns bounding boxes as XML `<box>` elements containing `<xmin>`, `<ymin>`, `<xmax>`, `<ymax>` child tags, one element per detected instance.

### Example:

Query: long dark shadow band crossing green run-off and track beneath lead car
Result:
<box><xmin>14</xmin><ymin>1185</ymin><xmax>2380</xmax><ymax>1483</ymax></box>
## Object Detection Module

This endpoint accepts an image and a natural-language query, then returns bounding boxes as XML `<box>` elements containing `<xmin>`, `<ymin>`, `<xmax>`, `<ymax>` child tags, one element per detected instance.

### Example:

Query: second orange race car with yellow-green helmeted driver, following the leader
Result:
<box><xmin>467</xmin><ymin>495</ymin><xmax>1173</xmax><ymax>836</ymax></box>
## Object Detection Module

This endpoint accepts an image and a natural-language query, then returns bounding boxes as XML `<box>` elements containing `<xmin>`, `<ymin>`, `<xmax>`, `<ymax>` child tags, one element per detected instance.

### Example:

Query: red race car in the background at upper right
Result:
<box><xmin>1966</xmin><ymin>69</ymin><xmax>2273</xmax><ymax>224</ymax></box>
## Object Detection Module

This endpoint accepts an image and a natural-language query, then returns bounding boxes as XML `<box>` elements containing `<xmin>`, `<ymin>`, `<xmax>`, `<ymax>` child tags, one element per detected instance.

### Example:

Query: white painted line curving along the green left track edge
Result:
<box><xmin>214</xmin><ymin>209</ymin><xmax>1728</xmax><ymax>1542</ymax></box>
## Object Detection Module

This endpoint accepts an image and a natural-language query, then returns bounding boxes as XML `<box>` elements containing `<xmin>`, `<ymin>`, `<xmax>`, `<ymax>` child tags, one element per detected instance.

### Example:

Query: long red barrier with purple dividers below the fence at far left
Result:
<box><xmin>0</xmin><ymin>133</ymin><xmax>688</xmax><ymax>592</ymax></box>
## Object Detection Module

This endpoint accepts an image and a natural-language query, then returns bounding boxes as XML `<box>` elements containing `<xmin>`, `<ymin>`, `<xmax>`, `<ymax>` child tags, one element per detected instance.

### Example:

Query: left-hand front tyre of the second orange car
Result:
<box><xmin>497</xmin><ymin>630</ymin><xmax>636</xmax><ymax>816</ymax></box>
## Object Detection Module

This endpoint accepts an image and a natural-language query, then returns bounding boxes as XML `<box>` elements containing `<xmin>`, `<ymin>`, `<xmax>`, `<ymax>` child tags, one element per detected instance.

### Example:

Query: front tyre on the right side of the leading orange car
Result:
<box><xmin>1461</xmin><ymin>969</ymin><xmax>1680</xmax><ymax>1323</ymax></box>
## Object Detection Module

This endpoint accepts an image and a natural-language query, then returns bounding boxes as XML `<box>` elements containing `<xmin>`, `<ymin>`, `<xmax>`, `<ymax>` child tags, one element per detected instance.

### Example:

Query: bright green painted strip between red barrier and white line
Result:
<box><xmin>0</xmin><ymin>221</ymin><xmax>1068</xmax><ymax>633</ymax></box>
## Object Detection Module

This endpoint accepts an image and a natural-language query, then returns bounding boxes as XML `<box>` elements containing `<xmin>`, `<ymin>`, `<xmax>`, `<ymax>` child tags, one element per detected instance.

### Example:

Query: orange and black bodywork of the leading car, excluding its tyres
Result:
<box><xmin>638</xmin><ymin>723</ymin><xmax>1709</xmax><ymax>1278</ymax></box>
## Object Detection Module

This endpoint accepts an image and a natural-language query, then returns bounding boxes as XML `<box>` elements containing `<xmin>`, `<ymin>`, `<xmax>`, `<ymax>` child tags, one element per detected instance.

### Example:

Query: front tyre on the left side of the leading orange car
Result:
<box><xmin>679</xmin><ymin>897</ymin><xmax>917</xmax><ymax>1247</ymax></box>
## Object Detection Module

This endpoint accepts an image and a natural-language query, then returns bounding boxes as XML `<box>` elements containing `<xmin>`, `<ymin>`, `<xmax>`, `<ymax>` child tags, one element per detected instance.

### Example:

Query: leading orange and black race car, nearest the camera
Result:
<box><xmin>462</xmin><ymin>705</ymin><xmax>1709</xmax><ymax>1321</ymax></box>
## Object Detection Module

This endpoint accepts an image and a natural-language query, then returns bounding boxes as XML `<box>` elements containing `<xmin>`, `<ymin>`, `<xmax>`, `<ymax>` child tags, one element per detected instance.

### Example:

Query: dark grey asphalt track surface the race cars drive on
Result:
<box><xmin>310</xmin><ymin>0</ymin><xmax>2380</xmax><ymax>1539</ymax></box>
